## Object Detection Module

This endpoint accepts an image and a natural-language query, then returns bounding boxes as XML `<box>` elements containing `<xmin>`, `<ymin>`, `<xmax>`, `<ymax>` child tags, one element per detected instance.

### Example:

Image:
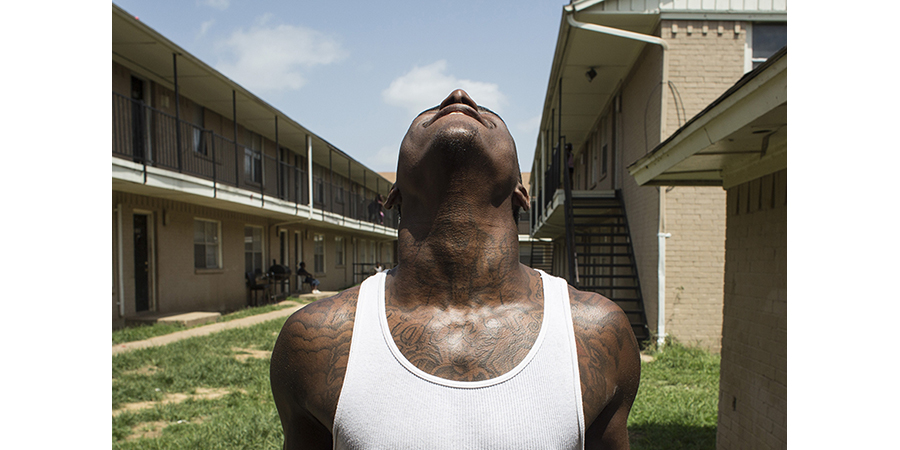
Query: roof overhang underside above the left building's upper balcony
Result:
<box><xmin>112</xmin><ymin>4</ymin><xmax>391</xmax><ymax>191</ymax></box>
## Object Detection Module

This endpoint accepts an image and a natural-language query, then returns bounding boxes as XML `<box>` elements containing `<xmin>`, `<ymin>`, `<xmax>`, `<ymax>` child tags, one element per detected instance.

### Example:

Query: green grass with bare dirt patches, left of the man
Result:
<box><xmin>112</xmin><ymin>318</ymin><xmax>286</xmax><ymax>449</ymax></box>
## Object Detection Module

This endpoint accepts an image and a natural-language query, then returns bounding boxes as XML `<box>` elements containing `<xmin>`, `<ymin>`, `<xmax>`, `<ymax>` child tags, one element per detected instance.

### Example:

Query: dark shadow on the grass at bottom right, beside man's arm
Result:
<box><xmin>628</xmin><ymin>424</ymin><xmax>716</xmax><ymax>450</ymax></box>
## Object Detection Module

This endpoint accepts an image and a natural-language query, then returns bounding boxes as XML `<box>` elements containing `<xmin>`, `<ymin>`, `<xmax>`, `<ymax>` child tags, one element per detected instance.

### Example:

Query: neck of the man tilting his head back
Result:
<box><xmin>390</xmin><ymin>195</ymin><xmax>527</xmax><ymax>307</ymax></box>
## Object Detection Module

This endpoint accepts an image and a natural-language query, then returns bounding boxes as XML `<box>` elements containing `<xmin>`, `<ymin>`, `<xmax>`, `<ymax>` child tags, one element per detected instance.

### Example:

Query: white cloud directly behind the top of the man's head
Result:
<box><xmin>381</xmin><ymin>59</ymin><xmax>506</xmax><ymax>114</ymax></box>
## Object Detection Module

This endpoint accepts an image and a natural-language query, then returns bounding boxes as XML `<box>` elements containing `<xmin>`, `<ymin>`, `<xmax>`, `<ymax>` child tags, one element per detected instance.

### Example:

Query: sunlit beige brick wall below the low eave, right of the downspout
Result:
<box><xmin>666</xmin><ymin>186</ymin><xmax>725</xmax><ymax>352</ymax></box>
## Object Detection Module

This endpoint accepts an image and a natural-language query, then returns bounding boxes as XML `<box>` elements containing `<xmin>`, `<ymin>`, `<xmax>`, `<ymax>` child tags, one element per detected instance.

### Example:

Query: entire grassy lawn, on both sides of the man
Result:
<box><xmin>112</xmin><ymin>312</ymin><xmax>719</xmax><ymax>450</ymax></box>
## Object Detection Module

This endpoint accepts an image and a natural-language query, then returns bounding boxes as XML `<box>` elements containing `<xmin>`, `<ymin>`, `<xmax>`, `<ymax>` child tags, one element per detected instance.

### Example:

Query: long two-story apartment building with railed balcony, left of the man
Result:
<box><xmin>111</xmin><ymin>5</ymin><xmax>398</xmax><ymax>327</ymax></box>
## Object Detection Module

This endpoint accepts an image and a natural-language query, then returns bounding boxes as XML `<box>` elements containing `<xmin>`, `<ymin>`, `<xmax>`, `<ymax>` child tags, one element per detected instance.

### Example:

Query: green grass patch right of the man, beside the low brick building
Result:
<box><xmin>628</xmin><ymin>343</ymin><xmax>719</xmax><ymax>450</ymax></box>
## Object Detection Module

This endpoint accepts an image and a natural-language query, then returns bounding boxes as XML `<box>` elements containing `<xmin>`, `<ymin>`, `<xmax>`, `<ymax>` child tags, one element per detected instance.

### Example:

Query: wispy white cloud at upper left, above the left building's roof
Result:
<box><xmin>216</xmin><ymin>16</ymin><xmax>347</xmax><ymax>91</ymax></box>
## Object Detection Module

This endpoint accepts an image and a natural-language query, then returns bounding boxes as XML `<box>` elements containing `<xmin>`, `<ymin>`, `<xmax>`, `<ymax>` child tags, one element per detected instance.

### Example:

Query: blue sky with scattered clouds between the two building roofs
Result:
<box><xmin>115</xmin><ymin>0</ymin><xmax>568</xmax><ymax>171</ymax></box>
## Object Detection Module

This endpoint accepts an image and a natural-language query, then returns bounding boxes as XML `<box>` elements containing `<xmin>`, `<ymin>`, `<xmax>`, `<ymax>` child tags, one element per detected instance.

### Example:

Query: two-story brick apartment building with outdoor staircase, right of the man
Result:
<box><xmin>530</xmin><ymin>0</ymin><xmax>787</xmax><ymax>351</ymax></box>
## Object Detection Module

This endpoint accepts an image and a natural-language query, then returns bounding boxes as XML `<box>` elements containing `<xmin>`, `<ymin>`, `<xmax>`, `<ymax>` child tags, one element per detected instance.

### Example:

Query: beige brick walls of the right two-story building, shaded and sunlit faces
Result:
<box><xmin>613</xmin><ymin>20</ymin><xmax>744</xmax><ymax>351</ymax></box>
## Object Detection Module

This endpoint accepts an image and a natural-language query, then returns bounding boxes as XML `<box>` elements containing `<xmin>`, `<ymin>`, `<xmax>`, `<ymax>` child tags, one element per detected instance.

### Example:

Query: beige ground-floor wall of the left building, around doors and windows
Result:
<box><xmin>112</xmin><ymin>191</ymin><xmax>387</xmax><ymax>327</ymax></box>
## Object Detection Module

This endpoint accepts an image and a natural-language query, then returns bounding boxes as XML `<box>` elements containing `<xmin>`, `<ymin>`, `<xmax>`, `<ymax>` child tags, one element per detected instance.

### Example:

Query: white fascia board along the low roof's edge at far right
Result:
<box><xmin>628</xmin><ymin>58</ymin><xmax>787</xmax><ymax>186</ymax></box>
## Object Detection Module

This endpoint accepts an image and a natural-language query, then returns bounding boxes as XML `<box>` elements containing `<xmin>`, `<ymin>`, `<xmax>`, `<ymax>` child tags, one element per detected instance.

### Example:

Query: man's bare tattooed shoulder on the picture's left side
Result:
<box><xmin>270</xmin><ymin>287</ymin><xmax>359</xmax><ymax>431</ymax></box>
